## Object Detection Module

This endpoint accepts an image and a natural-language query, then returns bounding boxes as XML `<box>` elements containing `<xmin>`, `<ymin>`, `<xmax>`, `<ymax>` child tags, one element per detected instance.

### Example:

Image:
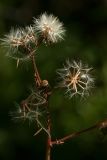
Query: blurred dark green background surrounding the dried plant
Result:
<box><xmin>0</xmin><ymin>0</ymin><xmax>107</xmax><ymax>160</ymax></box>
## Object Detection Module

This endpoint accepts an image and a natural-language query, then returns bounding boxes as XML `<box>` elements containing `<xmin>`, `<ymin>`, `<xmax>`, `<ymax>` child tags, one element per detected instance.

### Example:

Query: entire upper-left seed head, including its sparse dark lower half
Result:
<box><xmin>2</xmin><ymin>26</ymin><xmax>37</xmax><ymax>60</ymax></box>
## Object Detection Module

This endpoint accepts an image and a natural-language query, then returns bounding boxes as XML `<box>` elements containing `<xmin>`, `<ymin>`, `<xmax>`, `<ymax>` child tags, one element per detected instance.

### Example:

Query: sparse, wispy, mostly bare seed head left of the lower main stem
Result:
<box><xmin>10</xmin><ymin>90</ymin><xmax>50</xmax><ymax>135</ymax></box>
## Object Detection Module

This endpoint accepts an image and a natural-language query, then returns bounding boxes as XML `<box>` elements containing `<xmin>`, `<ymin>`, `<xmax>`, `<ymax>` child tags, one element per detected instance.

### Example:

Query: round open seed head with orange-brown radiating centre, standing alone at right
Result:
<box><xmin>57</xmin><ymin>60</ymin><xmax>94</xmax><ymax>98</ymax></box>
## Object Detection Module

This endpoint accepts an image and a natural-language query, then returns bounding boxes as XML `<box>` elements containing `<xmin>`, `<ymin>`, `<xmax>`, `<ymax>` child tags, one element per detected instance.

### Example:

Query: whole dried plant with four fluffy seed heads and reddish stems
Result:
<box><xmin>2</xmin><ymin>13</ymin><xmax>107</xmax><ymax>160</ymax></box>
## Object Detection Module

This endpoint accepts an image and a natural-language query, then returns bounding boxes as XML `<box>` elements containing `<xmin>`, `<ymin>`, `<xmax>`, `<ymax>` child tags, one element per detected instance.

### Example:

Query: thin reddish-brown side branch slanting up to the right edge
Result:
<box><xmin>51</xmin><ymin>119</ymin><xmax>107</xmax><ymax>145</ymax></box>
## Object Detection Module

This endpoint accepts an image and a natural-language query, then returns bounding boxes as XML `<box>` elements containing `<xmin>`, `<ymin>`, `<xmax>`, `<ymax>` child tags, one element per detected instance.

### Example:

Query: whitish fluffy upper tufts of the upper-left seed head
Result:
<box><xmin>2</xmin><ymin>26</ymin><xmax>36</xmax><ymax>48</ymax></box>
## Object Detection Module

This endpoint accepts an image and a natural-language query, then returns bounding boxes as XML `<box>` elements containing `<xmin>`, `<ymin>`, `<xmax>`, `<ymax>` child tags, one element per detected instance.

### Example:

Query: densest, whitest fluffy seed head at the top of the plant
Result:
<box><xmin>34</xmin><ymin>13</ymin><xmax>65</xmax><ymax>43</ymax></box>
